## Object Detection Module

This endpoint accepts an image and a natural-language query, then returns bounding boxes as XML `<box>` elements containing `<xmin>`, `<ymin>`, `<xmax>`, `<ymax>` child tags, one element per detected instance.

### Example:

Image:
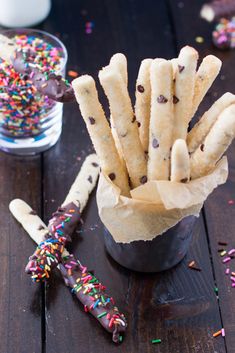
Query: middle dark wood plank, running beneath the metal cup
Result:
<box><xmin>44</xmin><ymin>0</ymin><xmax>225</xmax><ymax>353</ymax></box>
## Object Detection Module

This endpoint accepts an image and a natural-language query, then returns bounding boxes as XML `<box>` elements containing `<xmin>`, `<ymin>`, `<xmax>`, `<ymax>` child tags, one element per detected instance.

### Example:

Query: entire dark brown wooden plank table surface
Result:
<box><xmin>0</xmin><ymin>0</ymin><xmax>235</xmax><ymax>353</ymax></box>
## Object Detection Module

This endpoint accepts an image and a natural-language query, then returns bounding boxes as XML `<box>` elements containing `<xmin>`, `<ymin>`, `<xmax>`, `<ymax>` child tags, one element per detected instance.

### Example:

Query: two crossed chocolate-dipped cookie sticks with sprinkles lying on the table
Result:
<box><xmin>9</xmin><ymin>154</ymin><xmax>127</xmax><ymax>343</ymax></box>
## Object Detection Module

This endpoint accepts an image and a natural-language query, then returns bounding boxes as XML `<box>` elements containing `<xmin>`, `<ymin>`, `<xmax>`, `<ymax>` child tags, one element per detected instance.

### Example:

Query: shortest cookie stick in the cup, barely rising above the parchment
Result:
<box><xmin>171</xmin><ymin>139</ymin><xmax>190</xmax><ymax>183</ymax></box>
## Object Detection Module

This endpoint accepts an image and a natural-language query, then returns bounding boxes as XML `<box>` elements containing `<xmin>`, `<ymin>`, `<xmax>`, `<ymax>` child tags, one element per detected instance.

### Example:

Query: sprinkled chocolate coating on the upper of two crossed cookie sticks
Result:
<box><xmin>25</xmin><ymin>202</ymin><xmax>81</xmax><ymax>282</ymax></box>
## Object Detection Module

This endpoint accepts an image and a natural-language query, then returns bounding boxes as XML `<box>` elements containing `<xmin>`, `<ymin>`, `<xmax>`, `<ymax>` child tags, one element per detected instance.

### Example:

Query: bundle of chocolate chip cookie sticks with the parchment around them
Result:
<box><xmin>72</xmin><ymin>46</ymin><xmax>235</xmax><ymax>242</ymax></box>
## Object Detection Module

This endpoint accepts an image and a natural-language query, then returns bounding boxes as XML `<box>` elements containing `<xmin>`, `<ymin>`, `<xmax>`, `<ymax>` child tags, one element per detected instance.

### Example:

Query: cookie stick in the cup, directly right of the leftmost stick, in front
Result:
<box><xmin>99</xmin><ymin>66</ymin><xmax>147</xmax><ymax>187</ymax></box>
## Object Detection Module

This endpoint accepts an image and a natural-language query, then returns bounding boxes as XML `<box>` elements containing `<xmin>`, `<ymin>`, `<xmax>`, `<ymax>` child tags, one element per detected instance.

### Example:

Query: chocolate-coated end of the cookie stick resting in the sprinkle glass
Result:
<box><xmin>12</xmin><ymin>51</ymin><xmax>75</xmax><ymax>103</ymax></box>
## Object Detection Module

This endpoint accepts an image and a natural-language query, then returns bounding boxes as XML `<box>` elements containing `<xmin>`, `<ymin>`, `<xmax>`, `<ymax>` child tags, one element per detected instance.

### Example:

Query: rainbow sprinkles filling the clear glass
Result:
<box><xmin>0</xmin><ymin>35</ymin><xmax>63</xmax><ymax>137</ymax></box>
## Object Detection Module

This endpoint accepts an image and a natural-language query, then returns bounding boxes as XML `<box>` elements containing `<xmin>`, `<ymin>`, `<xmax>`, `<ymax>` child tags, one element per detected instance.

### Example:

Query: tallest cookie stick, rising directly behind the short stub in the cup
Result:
<box><xmin>173</xmin><ymin>46</ymin><xmax>198</xmax><ymax>142</ymax></box>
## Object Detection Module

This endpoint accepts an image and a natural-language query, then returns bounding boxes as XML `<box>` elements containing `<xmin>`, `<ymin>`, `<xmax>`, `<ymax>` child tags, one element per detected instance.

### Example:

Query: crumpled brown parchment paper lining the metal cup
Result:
<box><xmin>97</xmin><ymin>157</ymin><xmax>228</xmax><ymax>243</ymax></box>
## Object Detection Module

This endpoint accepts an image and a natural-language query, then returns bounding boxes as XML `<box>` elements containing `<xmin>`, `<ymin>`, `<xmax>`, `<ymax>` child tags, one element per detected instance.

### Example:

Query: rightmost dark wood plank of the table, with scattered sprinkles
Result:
<box><xmin>170</xmin><ymin>1</ymin><xmax>235</xmax><ymax>353</ymax></box>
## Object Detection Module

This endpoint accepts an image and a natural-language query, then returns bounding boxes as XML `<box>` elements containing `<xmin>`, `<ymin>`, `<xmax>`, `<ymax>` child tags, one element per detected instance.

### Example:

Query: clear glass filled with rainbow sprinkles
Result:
<box><xmin>0</xmin><ymin>29</ymin><xmax>67</xmax><ymax>155</ymax></box>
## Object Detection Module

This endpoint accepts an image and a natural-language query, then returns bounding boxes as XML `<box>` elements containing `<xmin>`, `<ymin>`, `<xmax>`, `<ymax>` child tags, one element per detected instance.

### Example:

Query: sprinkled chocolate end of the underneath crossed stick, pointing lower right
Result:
<box><xmin>59</xmin><ymin>254</ymin><xmax>127</xmax><ymax>343</ymax></box>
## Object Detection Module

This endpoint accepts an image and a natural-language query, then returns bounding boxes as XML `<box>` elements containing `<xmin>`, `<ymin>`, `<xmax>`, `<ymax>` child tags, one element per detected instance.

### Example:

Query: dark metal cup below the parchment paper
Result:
<box><xmin>104</xmin><ymin>216</ymin><xmax>197</xmax><ymax>272</ymax></box>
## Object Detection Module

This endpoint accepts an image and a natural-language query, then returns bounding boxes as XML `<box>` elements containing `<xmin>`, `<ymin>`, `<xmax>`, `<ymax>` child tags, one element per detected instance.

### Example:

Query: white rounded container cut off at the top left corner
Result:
<box><xmin>0</xmin><ymin>0</ymin><xmax>51</xmax><ymax>28</ymax></box>
